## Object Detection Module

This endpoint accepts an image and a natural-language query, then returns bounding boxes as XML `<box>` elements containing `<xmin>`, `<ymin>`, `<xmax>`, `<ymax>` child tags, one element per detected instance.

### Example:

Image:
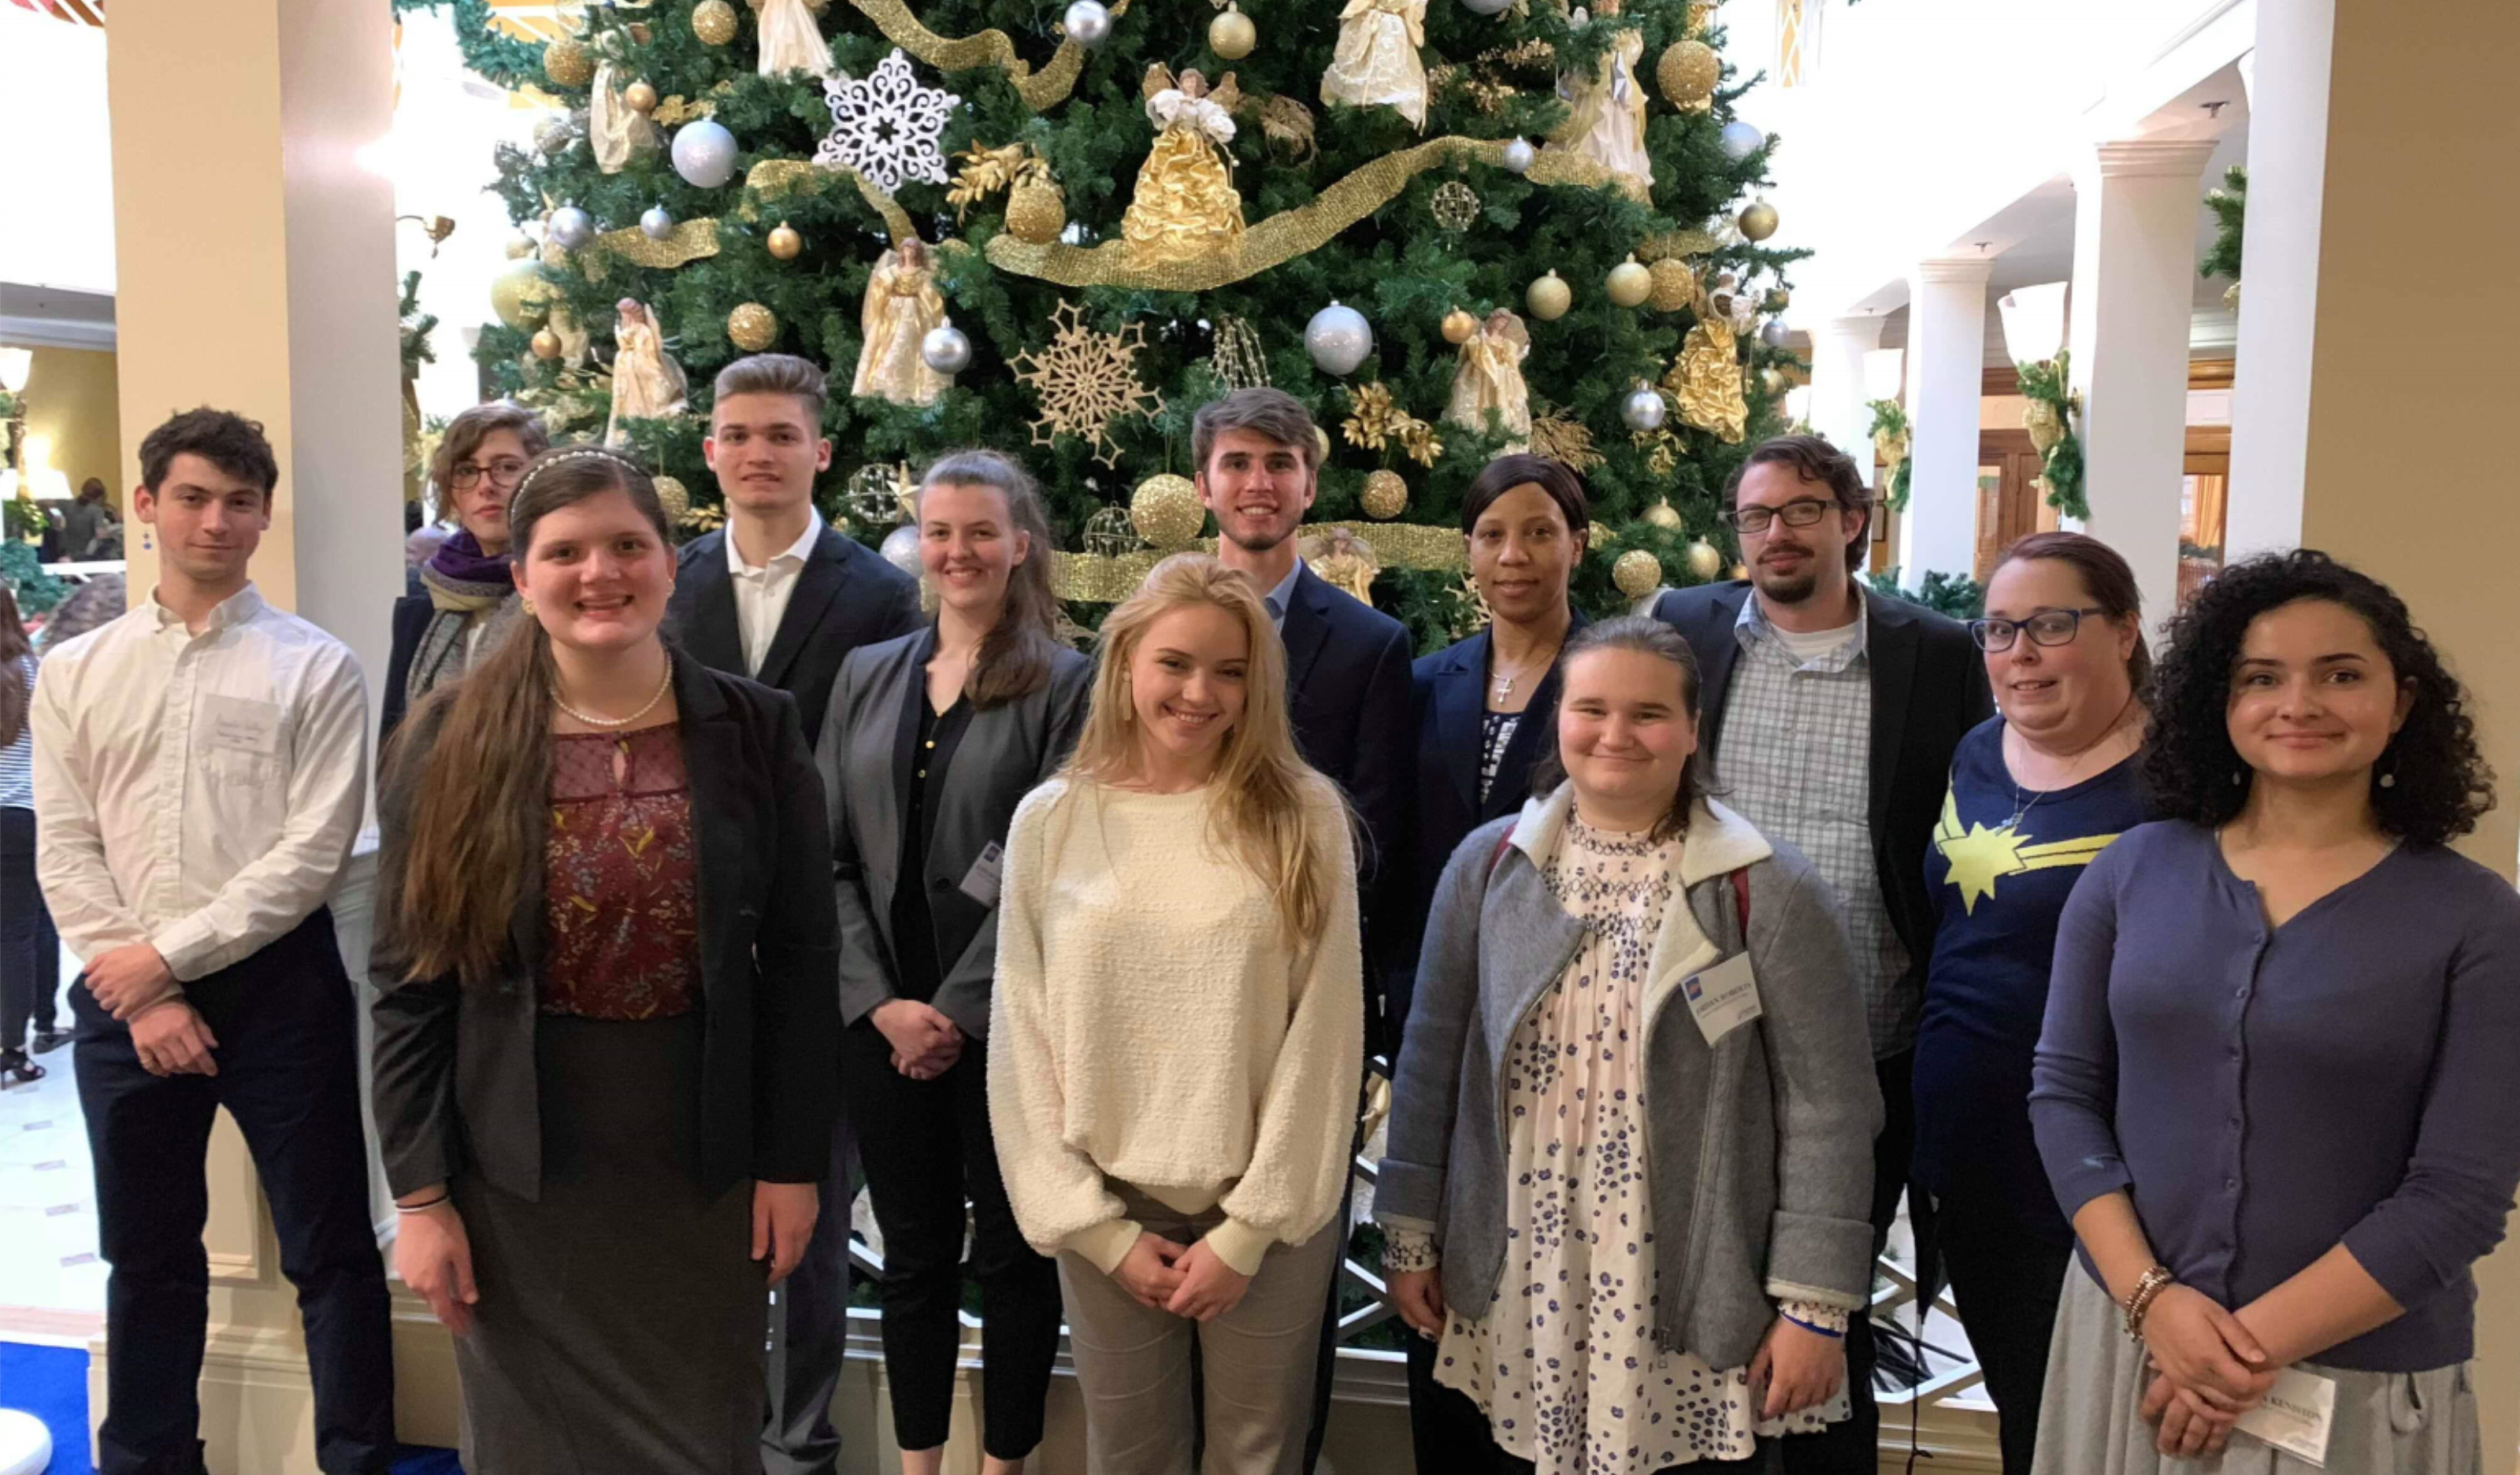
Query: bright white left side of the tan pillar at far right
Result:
<box><xmin>2223</xmin><ymin>0</ymin><xmax>2336</xmax><ymax>560</ymax></box>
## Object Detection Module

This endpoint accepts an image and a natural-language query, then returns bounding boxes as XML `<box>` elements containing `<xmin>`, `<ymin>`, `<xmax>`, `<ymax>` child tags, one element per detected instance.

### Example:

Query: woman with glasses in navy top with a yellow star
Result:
<box><xmin>1913</xmin><ymin>532</ymin><xmax>2152</xmax><ymax>1475</ymax></box>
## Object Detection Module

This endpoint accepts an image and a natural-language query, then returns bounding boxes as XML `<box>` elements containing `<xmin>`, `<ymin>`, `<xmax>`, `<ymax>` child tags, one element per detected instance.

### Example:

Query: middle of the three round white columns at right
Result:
<box><xmin>1900</xmin><ymin>258</ymin><xmax>1996</xmax><ymax>590</ymax></box>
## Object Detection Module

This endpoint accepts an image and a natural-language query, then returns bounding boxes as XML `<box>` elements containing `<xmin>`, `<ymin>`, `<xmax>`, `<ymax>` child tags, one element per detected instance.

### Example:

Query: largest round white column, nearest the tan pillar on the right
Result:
<box><xmin>2066</xmin><ymin>139</ymin><xmax>2213</xmax><ymax>628</ymax></box>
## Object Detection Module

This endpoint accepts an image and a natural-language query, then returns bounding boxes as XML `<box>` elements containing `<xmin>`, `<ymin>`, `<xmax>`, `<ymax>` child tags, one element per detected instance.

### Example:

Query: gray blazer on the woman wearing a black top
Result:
<box><xmin>816</xmin><ymin>625</ymin><xmax>1093</xmax><ymax>1039</ymax></box>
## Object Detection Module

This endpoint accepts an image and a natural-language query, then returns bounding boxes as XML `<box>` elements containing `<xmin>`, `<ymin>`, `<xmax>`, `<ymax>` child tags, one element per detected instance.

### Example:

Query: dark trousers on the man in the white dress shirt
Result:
<box><xmin>71</xmin><ymin>908</ymin><xmax>393</xmax><ymax>1475</ymax></box>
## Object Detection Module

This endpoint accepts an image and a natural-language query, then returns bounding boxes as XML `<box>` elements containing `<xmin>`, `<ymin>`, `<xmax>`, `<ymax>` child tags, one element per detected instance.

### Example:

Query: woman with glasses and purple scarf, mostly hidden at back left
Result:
<box><xmin>376</xmin><ymin>398</ymin><xmax>552</xmax><ymax>751</ymax></box>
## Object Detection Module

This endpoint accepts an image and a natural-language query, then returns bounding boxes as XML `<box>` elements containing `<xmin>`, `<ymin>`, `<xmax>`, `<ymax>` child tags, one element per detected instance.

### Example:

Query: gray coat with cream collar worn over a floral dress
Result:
<box><xmin>1376</xmin><ymin>787</ymin><xmax>1883</xmax><ymax>1369</ymax></box>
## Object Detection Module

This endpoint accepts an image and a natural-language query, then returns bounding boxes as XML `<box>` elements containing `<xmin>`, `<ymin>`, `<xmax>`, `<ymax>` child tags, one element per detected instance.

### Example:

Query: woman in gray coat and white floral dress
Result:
<box><xmin>1376</xmin><ymin>617</ymin><xmax>1883</xmax><ymax>1475</ymax></box>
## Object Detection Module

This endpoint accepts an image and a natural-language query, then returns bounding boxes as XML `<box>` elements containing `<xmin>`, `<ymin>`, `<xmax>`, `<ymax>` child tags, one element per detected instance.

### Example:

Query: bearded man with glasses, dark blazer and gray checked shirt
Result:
<box><xmin>1653</xmin><ymin>436</ymin><xmax>1993</xmax><ymax>1475</ymax></box>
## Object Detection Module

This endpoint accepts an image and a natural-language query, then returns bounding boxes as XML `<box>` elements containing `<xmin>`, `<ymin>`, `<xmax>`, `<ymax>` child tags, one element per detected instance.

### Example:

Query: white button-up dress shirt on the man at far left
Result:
<box><xmin>30</xmin><ymin>585</ymin><xmax>368</xmax><ymax>980</ymax></box>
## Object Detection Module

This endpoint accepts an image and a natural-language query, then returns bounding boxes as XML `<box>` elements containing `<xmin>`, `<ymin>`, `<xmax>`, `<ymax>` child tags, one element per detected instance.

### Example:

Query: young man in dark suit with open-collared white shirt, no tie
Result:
<box><xmin>666</xmin><ymin>353</ymin><xmax>920</xmax><ymax>1475</ymax></box>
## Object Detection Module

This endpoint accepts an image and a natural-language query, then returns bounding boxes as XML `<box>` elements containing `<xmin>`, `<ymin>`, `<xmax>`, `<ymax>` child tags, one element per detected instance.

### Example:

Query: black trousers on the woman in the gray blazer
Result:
<box><xmin>839</xmin><ymin>1018</ymin><xmax>1061</xmax><ymax>1460</ymax></box>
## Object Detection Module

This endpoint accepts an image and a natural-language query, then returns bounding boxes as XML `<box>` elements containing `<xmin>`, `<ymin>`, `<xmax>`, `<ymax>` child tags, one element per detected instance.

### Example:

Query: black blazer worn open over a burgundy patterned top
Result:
<box><xmin>368</xmin><ymin>655</ymin><xmax>839</xmax><ymax>1198</ymax></box>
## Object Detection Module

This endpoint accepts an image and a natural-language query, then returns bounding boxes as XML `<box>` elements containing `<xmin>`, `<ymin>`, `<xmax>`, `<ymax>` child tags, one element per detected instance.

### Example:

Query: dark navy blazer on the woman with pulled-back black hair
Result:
<box><xmin>1383</xmin><ymin>610</ymin><xmax>1590</xmax><ymax>1039</ymax></box>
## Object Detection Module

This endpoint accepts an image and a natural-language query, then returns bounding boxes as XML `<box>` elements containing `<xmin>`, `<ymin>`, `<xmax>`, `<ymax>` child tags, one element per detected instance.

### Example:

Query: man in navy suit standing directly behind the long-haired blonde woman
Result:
<box><xmin>1189</xmin><ymin>388</ymin><xmax>1416</xmax><ymax>1470</ymax></box>
